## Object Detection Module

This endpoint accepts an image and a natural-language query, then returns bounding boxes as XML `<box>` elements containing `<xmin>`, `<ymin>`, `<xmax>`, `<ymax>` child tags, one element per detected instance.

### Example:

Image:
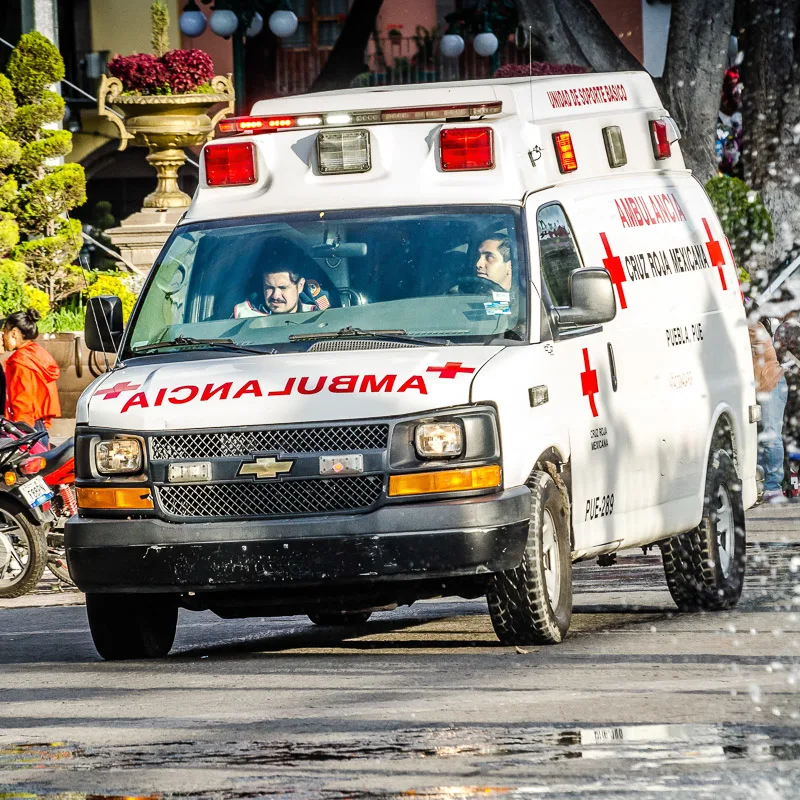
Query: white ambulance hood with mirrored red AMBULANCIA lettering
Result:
<box><xmin>86</xmin><ymin>346</ymin><xmax>503</xmax><ymax>431</ymax></box>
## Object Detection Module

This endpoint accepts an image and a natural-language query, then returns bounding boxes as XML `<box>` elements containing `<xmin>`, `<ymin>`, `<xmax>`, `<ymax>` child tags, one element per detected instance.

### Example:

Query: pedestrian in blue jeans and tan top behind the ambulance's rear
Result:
<box><xmin>748</xmin><ymin>321</ymin><xmax>789</xmax><ymax>503</ymax></box>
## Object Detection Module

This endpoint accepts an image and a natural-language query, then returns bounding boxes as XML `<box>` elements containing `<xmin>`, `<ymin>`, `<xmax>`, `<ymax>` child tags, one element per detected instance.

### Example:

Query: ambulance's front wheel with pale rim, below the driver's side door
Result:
<box><xmin>486</xmin><ymin>472</ymin><xmax>572</xmax><ymax>645</ymax></box>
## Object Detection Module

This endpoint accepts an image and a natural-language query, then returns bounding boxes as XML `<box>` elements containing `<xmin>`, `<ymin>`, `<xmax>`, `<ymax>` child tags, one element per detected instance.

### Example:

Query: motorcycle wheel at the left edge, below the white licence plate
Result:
<box><xmin>0</xmin><ymin>509</ymin><xmax>47</xmax><ymax>597</ymax></box>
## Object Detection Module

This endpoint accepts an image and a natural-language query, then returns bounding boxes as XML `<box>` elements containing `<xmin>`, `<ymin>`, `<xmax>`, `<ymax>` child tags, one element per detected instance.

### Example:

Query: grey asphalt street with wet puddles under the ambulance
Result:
<box><xmin>0</xmin><ymin>504</ymin><xmax>800</xmax><ymax>800</ymax></box>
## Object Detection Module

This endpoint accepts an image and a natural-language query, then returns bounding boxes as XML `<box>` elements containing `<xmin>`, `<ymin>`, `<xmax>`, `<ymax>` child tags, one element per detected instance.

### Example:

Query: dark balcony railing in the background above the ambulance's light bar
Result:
<box><xmin>275</xmin><ymin>37</ymin><xmax>528</xmax><ymax>96</ymax></box>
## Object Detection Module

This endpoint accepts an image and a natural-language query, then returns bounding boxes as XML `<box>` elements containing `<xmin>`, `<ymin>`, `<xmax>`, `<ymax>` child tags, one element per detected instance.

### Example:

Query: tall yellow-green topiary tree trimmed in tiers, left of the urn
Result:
<box><xmin>0</xmin><ymin>31</ymin><xmax>86</xmax><ymax>303</ymax></box>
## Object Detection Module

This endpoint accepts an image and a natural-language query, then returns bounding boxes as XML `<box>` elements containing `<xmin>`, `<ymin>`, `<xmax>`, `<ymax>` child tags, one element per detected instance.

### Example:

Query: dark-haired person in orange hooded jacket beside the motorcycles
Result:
<box><xmin>3</xmin><ymin>308</ymin><xmax>61</xmax><ymax>446</ymax></box>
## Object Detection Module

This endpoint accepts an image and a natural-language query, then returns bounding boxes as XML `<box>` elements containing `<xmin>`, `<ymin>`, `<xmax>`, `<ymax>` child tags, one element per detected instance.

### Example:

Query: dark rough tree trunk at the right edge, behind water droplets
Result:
<box><xmin>736</xmin><ymin>0</ymin><xmax>800</xmax><ymax>258</ymax></box>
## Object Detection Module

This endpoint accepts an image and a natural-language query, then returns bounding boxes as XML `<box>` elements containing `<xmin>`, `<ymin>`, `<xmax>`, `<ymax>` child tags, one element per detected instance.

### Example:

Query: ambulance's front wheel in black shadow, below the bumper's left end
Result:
<box><xmin>86</xmin><ymin>593</ymin><xmax>178</xmax><ymax>661</ymax></box>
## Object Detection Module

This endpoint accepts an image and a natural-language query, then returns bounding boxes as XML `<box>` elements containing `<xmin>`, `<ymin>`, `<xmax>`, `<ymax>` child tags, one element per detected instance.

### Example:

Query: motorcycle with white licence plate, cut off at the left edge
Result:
<box><xmin>0</xmin><ymin>420</ymin><xmax>55</xmax><ymax>598</ymax></box>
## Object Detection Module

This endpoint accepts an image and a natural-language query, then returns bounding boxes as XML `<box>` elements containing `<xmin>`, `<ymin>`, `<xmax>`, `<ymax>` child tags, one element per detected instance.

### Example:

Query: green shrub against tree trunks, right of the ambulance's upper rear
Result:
<box><xmin>706</xmin><ymin>176</ymin><xmax>774</xmax><ymax>281</ymax></box>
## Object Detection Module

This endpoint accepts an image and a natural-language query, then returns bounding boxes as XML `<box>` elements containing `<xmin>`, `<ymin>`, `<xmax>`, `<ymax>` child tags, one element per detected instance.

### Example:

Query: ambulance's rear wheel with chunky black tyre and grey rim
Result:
<box><xmin>661</xmin><ymin>450</ymin><xmax>746</xmax><ymax>611</ymax></box>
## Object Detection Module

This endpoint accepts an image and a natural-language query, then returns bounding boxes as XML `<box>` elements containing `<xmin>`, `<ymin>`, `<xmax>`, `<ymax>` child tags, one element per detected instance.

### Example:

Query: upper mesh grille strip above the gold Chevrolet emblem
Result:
<box><xmin>150</xmin><ymin>425</ymin><xmax>389</xmax><ymax>461</ymax></box>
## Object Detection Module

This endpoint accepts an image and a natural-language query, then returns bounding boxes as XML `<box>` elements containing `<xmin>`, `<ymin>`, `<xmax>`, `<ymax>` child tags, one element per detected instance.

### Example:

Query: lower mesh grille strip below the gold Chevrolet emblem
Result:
<box><xmin>156</xmin><ymin>475</ymin><xmax>383</xmax><ymax>518</ymax></box>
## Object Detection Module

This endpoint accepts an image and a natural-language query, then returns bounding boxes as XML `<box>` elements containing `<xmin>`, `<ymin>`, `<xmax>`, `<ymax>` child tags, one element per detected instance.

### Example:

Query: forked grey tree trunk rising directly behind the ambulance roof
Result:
<box><xmin>517</xmin><ymin>0</ymin><xmax>736</xmax><ymax>182</ymax></box>
